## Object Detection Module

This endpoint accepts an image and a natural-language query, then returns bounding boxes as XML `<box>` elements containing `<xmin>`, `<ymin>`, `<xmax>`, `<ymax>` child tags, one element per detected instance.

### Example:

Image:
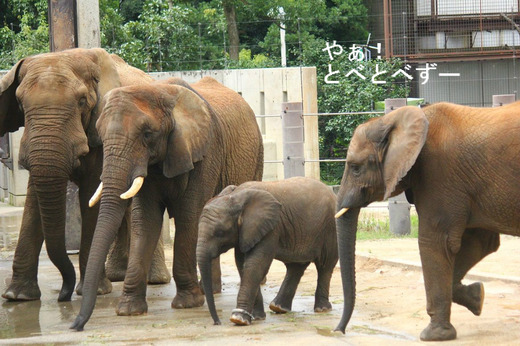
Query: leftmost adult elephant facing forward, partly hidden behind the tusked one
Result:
<box><xmin>0</xmin><ymin>48</ymin><xmax>169</xmax><ymax>301</ymax></box>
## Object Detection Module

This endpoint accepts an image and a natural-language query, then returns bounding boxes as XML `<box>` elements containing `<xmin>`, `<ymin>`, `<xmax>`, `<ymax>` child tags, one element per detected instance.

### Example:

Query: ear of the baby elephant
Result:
<box><xmin>233</xmin><ymin>189</ymin><xmax>282</xmax><ymax>253</ymax></box>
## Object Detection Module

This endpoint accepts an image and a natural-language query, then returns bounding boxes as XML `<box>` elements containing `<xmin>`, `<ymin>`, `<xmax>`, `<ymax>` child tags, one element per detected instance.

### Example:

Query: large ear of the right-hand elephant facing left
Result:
<box><xmin>381</xmin><ymin>106</ymin><xmax>428</xmax><ymax>199</ymax></box>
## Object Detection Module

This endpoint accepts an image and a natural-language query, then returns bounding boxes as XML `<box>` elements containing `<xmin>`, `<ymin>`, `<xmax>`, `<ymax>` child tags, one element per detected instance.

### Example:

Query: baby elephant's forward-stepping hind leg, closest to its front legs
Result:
<box><xmin>269</xmin><ymin>262</ymin><xmax>310</xmax><ymax>314</ymax></box>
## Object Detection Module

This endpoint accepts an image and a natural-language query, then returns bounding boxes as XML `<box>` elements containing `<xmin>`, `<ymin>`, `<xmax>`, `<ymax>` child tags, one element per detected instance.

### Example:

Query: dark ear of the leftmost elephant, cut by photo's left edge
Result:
<box><xmin>0</xmin><ymin>59</ymin><xmax>25</xmax><ymax>136</ymax></box>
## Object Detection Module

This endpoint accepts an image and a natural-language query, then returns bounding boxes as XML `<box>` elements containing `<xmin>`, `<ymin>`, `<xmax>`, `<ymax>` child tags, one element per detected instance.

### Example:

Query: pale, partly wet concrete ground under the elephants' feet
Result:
<box><xmin>0</xmin><ymin>206</ymin><xmax>520</xmax><ymax>345</ymax></box>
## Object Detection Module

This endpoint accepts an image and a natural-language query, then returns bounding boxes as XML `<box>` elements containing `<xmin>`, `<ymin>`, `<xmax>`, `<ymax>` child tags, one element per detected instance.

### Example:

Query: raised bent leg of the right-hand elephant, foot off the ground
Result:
<box><xmin>452</xmin><ymin>229</ymin><xmax>500</xmax><ymax>316</ymax></box>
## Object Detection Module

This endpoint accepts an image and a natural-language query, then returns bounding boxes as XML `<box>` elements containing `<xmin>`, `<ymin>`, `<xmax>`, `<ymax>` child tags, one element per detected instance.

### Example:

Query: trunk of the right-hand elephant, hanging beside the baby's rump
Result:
<box><xmin>335</xmin><ymin>208</ymin><xmax>360</xmax><ymax>334</ymax></box>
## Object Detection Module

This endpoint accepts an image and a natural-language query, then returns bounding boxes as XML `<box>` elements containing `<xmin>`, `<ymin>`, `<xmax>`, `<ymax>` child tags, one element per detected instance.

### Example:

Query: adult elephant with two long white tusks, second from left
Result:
<box><xmin>71</xmin><ymin>77</ymin><xmax>263</xmax><ymax>330</ymax></box>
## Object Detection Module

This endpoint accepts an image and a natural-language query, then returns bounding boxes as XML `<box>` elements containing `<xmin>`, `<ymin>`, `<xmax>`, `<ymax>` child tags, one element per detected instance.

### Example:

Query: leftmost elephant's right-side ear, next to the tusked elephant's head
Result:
<box><xmin>85</xmin><ymin>48</ymin><xmax>121</xmax><ymax>147</ymax></box>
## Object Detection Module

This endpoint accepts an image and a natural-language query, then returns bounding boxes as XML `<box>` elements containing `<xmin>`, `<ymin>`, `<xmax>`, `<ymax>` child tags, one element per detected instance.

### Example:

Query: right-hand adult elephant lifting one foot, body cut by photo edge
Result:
<box><xmin>337</xmin><ymin>102</ymin><xmax>520</xmax><ymax>341</ymax></box>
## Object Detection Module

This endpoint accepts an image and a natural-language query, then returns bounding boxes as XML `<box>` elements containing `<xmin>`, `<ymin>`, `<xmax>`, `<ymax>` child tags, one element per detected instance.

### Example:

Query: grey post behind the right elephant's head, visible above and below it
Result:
<box><xmin>385</xmin><ymin>99</ymin><xmax>411</xmax><ymax>235</ymax></box>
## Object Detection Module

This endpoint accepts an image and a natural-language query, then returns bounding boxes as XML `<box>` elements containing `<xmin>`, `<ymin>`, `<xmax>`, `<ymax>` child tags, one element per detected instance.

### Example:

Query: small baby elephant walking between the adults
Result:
<box><xmin>197</xmin><ymin>177</ymin><xmax>338</xmax><ymax>325</ymax></box>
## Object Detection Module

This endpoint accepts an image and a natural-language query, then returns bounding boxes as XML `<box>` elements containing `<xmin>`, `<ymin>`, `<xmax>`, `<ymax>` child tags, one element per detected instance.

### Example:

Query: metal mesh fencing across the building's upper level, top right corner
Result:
<box><xmin>383</xmin><ymin>0</ymin><xmax>520</xmax><ymax>61</ymax></box>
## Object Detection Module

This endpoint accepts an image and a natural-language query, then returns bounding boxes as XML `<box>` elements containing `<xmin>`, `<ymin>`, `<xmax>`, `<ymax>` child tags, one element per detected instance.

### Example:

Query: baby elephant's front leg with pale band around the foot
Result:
<box><xmin>230</xmin><ymin>241</ymin><xmax>276</xmax><ymax>325</ymax></box>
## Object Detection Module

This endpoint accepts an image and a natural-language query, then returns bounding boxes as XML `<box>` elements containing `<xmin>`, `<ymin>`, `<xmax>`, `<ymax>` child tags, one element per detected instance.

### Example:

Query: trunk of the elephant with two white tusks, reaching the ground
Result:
<box><xmin>71</xmin><ymin>169</ymin><xmax>128</xmax><ymax>331</ymax></box>
